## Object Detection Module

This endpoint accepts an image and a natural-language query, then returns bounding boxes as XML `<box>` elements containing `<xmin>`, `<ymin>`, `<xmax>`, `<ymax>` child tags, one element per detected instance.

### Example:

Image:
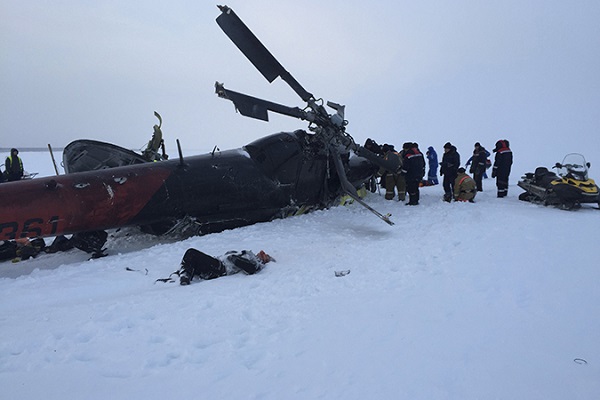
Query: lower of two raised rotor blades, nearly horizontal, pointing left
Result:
<box><xmin>215</xmin><ymin>82</ymin><xmax>313</xmax><ymax>121</ymax></box>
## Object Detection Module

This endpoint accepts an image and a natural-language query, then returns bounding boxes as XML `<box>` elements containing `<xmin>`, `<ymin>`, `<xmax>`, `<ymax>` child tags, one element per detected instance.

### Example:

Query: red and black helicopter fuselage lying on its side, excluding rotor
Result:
<box><xmin>0</xmin><ymin>131</ymin><xmax>376</xmax><ymax>240</ymax></box>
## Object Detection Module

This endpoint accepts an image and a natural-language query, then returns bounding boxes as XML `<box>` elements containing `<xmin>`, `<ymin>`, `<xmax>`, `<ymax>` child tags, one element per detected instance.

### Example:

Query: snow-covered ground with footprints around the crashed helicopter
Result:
<box><xmin>0</xmin><ymin>153</ymin><xmax>600</xmax><ymax>400</ymax></box>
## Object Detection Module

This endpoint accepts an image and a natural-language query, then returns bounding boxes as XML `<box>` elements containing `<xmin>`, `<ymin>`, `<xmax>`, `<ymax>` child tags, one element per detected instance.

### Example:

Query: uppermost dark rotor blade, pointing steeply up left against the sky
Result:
<box><xmin>217</xmin><ymin>6</ymin><xmax>313</xmax><ymax>101</ymax></box>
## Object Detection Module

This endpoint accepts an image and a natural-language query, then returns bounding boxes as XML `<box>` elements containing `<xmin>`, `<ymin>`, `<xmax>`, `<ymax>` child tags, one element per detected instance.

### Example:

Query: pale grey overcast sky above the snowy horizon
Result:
<box><xmin>0</xmin><ymin>0</ymin><xmax>600</xmax><ymax>165</ymax></box>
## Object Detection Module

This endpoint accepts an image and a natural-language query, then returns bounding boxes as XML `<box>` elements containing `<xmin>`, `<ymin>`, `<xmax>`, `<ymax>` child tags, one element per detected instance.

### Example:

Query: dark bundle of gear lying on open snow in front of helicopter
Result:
<box><xmin>174</xmin><ymin>248</ymin><xmax>275</xmax><ymax>285</ymax></box>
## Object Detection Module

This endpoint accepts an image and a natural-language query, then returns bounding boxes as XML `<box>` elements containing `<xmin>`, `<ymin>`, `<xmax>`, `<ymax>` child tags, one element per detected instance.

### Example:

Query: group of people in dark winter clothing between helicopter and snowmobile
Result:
<box><xmin>365</xmin><ymin>139</ymin><xmax>513</xmax><ymax>205</ymax></box>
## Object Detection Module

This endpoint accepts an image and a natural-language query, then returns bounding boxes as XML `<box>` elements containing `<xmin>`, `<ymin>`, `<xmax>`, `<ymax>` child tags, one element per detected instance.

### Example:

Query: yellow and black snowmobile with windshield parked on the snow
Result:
<box><xmin>518</xmin><ymin>153</ymin><xmax>600</xmax><ymax>210</ymax></box>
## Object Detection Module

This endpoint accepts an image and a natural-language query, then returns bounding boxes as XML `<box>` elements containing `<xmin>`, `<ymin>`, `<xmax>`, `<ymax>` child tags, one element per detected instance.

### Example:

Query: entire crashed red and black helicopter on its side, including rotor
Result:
<box><xmin>0</xmin><ymin>6</ymin><xmax>397</xmax><ymax>257</ymax></box>
